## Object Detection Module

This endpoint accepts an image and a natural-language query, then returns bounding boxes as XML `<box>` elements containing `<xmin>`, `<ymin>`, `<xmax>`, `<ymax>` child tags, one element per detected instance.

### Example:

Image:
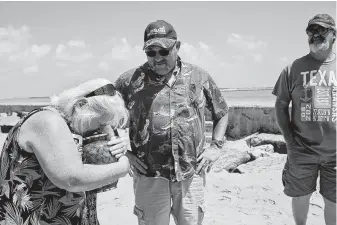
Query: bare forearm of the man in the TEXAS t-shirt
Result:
<box><xmin>275</xmin><ymin>97</ymin><xmax>295</xmax><ymax>144</ymax></box>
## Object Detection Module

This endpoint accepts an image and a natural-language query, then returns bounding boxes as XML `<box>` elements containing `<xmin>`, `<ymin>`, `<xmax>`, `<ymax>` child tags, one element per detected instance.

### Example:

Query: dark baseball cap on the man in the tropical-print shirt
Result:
<box><xmin>143</xmin><ymin>20</ymin><xmax>177</xmax><ymax>49</ymax></box>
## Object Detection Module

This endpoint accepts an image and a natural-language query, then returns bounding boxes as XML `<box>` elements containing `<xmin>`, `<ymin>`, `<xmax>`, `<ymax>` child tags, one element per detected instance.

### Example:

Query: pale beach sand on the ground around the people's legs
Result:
<box><xmin>0</xmin><ymin>134</ymin><xmax>324</xmax><ymax>225</ymax></box>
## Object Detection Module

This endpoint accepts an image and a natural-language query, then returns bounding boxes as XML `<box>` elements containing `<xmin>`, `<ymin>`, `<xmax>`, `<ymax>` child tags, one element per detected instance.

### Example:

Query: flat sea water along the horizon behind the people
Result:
<box><xmin>0</xmin><ymin>89</ymin><xmax>276</xmax><ymax>106</ymax></box>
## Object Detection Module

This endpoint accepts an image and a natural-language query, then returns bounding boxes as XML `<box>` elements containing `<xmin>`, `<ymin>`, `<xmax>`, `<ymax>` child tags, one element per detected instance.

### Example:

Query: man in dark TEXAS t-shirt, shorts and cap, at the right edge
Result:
<box><xmin>273</xmin><ymin>14</ymin><xmax>337</xmax><ymax>225</ymax></box>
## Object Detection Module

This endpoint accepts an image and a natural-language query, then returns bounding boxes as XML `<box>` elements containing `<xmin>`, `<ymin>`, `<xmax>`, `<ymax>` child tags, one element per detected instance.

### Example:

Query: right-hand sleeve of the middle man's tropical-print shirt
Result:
<box><xmin>203</xmin><ymin>72</ymin><xmax>228</xmax><ymax>121</ymax></box>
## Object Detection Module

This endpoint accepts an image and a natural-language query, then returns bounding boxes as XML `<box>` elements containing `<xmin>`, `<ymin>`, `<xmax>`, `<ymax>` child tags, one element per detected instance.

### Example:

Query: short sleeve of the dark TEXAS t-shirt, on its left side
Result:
<box><xmin>272</xmin><ymin>67</ymin><xmax>291</xmax><ymax>102</ymax></box>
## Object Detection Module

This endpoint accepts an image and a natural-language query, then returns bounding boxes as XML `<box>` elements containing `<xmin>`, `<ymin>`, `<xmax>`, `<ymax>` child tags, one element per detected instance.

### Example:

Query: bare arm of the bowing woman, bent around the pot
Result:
<box><xmin>20</xmin><ymin>111</ymin><xmax>129</xmax><ymax>192</ymax></box>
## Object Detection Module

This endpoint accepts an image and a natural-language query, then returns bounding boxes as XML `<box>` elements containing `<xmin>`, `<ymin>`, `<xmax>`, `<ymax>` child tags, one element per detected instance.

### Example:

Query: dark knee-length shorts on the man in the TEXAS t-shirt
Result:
<box><xmin>282</xmin><ymin>145</ymin><xmax>336</xmax><ymax>203</ymax></box>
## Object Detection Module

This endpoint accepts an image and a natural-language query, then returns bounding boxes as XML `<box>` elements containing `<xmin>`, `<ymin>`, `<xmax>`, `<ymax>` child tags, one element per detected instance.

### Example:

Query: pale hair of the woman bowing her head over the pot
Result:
<box><xmin>51</xmin><ymin>78</ymin><xmax>128</xmax><ymax>133</ymax></box>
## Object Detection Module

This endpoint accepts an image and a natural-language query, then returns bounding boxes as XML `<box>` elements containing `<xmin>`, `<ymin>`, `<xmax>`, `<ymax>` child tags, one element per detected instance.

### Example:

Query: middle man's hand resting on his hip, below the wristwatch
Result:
<box><xmin>196</xmin><ymin>145</ymin><xmax>221</xmax><ymax>174</ymax></box>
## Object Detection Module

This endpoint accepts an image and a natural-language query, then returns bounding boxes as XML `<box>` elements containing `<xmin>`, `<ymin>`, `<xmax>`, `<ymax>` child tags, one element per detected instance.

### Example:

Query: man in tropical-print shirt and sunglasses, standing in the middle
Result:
<box><xmin>115</xmin><ymin>20</ymin><xmax>228</xmax><ymax>225</ymax></box>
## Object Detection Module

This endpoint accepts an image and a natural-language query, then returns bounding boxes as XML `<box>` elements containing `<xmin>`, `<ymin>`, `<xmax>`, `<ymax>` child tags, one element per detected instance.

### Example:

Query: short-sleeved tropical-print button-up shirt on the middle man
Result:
<box><xmin>115</xmin><ymin>58</ymin><xmax>228</xmax><ymax>181</ymax></box>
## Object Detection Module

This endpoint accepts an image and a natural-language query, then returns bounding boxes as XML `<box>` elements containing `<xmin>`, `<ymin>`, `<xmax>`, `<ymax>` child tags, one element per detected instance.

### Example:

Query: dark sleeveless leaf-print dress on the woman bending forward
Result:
<box><xmin>0</xmin><ymin>108</ymin><xmax>99</xmax><ymax>225</ymax></box>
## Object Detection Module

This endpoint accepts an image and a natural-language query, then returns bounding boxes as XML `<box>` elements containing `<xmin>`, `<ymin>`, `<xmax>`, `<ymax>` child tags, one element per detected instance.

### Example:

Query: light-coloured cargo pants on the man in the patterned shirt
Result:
<box><xmin>133</xmin><ymin>173</ymin><xmax>205</xmax><ymax>225</ymax></box>
